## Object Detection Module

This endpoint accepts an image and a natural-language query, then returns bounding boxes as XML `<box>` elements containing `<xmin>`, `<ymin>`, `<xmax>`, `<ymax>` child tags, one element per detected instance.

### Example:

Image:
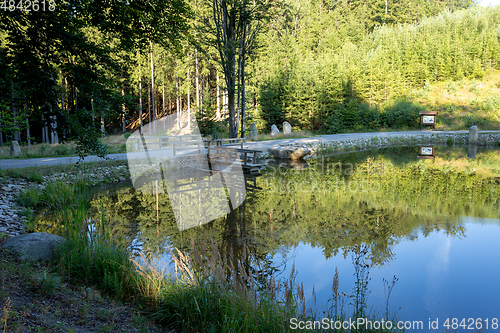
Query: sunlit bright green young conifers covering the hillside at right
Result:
<box><xmin>254</xmin><ymin>3</ymin><xmax>500</xmax><ymax>133</ymax></box>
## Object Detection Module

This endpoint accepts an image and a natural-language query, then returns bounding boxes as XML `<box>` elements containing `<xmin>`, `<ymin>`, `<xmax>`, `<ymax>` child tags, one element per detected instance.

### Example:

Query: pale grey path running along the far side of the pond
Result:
<box><xmin>0</xmin><ymin>130</ymin><xmax>500</xmax><ymax>169</ymax></box>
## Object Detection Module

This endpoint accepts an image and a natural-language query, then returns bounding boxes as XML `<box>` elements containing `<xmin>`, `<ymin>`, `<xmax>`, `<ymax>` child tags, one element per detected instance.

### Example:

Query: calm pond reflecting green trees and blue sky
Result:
<box><xmin>39</xmin><ymin>147</ymin><xmax>500</xmax><ymax>331</ymax></box>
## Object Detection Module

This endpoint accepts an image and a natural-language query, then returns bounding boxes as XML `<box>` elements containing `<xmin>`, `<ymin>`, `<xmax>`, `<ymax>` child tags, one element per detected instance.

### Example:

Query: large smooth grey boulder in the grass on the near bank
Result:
<box><xmin>2</xmin><ymin>232</ymin><xmax>66</xmax><ymax>261</ymax></box>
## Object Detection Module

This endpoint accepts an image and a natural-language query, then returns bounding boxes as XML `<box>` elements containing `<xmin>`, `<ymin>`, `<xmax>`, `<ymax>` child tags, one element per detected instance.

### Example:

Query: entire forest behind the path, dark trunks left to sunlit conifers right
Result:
<box><xmin>0</xmin><ymin>0</ymin><xmax>500</xmax><ymax>155</ymax></box>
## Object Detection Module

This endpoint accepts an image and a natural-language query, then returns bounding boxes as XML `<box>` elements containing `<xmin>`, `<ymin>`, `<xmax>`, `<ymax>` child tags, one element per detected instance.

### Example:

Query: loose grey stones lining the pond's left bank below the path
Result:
<box><xmin>0</xmin><ymin>165</ymin><xmax>130</xmax><ymax>237</ymax></box>
